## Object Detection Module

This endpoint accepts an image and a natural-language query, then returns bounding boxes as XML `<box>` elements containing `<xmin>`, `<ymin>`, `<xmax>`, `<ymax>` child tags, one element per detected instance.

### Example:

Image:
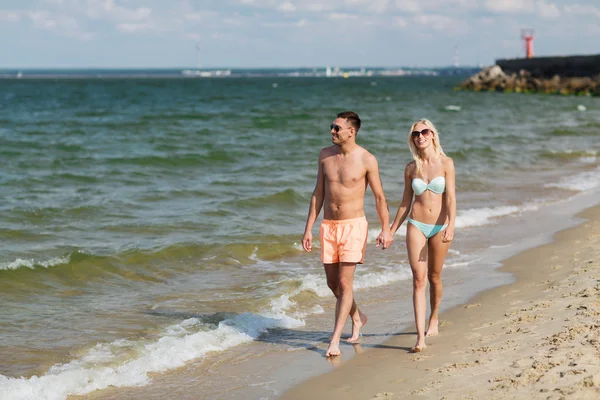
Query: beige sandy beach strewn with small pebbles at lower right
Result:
<box><xmin>281</xmin><ymin>206</ymin><xmax>600</xmax><ymax>400</ymax></box>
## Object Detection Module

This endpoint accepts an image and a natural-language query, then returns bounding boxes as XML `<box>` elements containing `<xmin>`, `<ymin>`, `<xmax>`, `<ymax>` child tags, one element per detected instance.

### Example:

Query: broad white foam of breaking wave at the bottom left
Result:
<box><xmin>0</xmin><ymin>310</ymin><xmax>304</xmax><ymax>400</ymax></box>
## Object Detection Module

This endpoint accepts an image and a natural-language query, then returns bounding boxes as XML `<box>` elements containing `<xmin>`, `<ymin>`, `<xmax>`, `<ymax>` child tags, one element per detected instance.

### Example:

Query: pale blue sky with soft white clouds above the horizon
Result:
<box><xmin>0</xmin><ymin>0</ymin><xmax>600</xmax><ymax>68</ymax></box>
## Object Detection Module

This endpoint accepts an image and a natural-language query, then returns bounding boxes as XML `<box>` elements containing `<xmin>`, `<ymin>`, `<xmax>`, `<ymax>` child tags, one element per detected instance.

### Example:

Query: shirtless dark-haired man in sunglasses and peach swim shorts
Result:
<box><xmin>302</xmin><ymin>111</ymin><xmax>393</xmax><ymax>357</ymax></box>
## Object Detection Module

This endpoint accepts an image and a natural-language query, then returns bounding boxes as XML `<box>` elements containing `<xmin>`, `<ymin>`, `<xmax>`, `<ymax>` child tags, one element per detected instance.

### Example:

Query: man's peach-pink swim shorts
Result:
<box><xmin>320</xmin><ymin>217</ymin><xmax>369</xmax><ymax>264</ymax></box>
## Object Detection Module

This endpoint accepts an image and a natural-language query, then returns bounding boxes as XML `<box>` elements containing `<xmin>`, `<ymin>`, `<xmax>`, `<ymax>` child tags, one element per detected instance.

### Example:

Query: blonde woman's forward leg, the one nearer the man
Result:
<box><xmin>406</xmin><ymin>223</ymin><xmax>427</xmax><ymax>351</ymax></box>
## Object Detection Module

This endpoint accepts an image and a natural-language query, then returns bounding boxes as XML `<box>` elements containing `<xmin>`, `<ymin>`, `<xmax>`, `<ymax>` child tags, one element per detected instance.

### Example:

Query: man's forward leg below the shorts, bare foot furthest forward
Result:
<box><xmin>325</xmin><ymin>263</ymin><xmax>356</xmax><ymax>357</ymax></box>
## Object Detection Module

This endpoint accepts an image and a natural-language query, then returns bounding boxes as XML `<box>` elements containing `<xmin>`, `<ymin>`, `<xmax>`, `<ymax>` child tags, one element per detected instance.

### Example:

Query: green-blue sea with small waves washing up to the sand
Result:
<box><xmin>0</xmin><ymin>72</ymin><xmax>600</xmax><ymax>400</ymax></box>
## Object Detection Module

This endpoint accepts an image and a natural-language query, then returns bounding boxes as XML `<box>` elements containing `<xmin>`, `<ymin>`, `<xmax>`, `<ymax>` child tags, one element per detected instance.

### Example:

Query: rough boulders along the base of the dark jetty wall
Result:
<box><xmin>459</xmin><ymin>65</ymin><xmax>600</xmax><ymax>96</ymax></box>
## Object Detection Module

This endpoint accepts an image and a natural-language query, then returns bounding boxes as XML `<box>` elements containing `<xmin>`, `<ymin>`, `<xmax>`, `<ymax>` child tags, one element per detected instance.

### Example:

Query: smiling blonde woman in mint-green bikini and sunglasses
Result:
<box><xmin>391</xmin><ymin>119</ymin><xmax>456</xmax><ymax>353</ymax></box>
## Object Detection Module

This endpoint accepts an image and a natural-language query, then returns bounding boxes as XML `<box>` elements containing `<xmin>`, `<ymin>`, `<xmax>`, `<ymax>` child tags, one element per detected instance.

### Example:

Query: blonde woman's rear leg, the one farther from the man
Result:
<box><xmin>426</xmin><ymin>231</ymin><xmax>450</xmax><ymax>336</ymax></box>
